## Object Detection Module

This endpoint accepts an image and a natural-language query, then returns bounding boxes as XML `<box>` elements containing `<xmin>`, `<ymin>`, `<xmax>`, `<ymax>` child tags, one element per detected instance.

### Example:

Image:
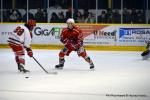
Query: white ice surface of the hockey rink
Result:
<box><xmin>0</xmin><ymin>49</ymin><xmax>150</xmax><ymax>100</ymax></box>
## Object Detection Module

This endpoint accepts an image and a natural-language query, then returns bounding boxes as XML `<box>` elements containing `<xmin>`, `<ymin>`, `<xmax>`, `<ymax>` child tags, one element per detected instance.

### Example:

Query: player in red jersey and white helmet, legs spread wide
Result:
<box><xmin>55</xmin><ymin>18</ymin><xmax>94</xmax><ymax>69</ymax></box>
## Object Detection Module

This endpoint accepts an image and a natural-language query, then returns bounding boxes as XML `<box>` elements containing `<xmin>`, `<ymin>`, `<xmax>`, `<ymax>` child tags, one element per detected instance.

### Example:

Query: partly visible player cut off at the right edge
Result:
<box><xmin>141</xmin><ymin>41</ymin><xmax>150</xmax><ymax>60</ymax></box>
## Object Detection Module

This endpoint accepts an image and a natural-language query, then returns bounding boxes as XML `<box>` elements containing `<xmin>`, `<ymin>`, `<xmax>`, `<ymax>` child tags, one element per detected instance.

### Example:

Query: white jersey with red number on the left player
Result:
<box><xmin>8</xmin><ymin>25</ymin><xmax>31</xmax><ymax>47</ymax></box>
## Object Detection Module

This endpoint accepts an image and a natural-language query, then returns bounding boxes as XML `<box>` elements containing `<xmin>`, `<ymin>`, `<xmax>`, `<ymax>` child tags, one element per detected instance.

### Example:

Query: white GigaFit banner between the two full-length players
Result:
<box><xmin>32</xmin><ymin>24</ymin><xmax>65</xmax><ymax>44</ymax></box>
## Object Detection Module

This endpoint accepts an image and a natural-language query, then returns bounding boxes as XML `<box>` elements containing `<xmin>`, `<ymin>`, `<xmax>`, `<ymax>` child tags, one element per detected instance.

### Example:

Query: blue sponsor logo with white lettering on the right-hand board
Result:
<box><xmin>119</xmin><ymin>28</ymin><xmax>150</xmax><ymax>38</ymax></box>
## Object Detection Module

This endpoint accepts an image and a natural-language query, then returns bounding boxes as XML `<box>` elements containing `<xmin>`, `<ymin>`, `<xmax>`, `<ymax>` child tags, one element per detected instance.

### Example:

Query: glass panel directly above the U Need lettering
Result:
<box><xmin>97</xmin><ymin>0</ymin><xmax>121</xmax><ymax>23</ymax></box>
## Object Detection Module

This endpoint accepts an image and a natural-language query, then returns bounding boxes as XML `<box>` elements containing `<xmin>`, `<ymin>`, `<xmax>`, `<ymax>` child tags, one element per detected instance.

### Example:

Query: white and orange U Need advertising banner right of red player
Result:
<box><xmin>83</xmin><ymin>25</ymin><xmax>117</xmax><ymax>46</ymax></box>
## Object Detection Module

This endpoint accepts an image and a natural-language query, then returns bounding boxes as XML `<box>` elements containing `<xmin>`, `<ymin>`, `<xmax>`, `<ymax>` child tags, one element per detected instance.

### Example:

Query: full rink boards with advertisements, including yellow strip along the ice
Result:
<box><xmin>0</xmin><ymin>23</ymin><xmax>150</xmax><ymax>51</ymax></box>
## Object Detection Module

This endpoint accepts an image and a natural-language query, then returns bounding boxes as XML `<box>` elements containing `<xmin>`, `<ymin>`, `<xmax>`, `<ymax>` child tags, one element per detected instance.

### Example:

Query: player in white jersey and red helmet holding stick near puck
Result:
<box><xmin>8</xmin><ymin>20</ymin><xmax>36</xmax><ymax>73</ymax></box>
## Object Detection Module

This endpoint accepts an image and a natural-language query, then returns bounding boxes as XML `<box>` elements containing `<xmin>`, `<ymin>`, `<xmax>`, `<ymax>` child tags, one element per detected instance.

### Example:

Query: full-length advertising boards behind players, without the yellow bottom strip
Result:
<box><xmin>0</xmin><ymin>23</ymin><xmax>150</xmax><ymax>46</ymax></box>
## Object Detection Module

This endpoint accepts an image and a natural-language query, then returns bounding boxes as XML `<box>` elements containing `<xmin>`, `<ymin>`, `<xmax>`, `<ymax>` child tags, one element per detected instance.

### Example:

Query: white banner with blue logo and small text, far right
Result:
<box><xmin>117</xmin><ymin>26</ymin><xmax>150</xmax><ymax>46</ymax></box>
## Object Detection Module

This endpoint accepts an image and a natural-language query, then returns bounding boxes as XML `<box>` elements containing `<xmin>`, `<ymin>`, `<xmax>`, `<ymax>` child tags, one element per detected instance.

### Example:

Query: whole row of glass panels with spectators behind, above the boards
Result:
<box><xmin>0</xmin><ymin>0</ymin><xmax>150</xmax><ymax>24</ymax></box>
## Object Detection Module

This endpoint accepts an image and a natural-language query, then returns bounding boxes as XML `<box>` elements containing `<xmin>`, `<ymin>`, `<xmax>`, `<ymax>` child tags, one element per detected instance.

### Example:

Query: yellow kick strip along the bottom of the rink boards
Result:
<box><xmin>0</xmin><ymin>44</ymin><xmax>145</xmax><ymax>51</ymax></box>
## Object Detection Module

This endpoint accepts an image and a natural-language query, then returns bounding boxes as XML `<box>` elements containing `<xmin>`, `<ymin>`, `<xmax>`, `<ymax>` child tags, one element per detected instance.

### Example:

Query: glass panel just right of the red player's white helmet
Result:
<box><xmin>73</xmin><ymin>0</ymin><xmax>96</xmax><ymax>23</ymax></box>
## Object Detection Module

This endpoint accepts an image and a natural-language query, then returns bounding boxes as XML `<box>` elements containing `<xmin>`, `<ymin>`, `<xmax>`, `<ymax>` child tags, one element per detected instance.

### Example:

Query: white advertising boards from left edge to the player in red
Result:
<box><xmin>0</xmin><ymin>24</ymin><xmax>66</xmax><ymax>44</ymax></box>
